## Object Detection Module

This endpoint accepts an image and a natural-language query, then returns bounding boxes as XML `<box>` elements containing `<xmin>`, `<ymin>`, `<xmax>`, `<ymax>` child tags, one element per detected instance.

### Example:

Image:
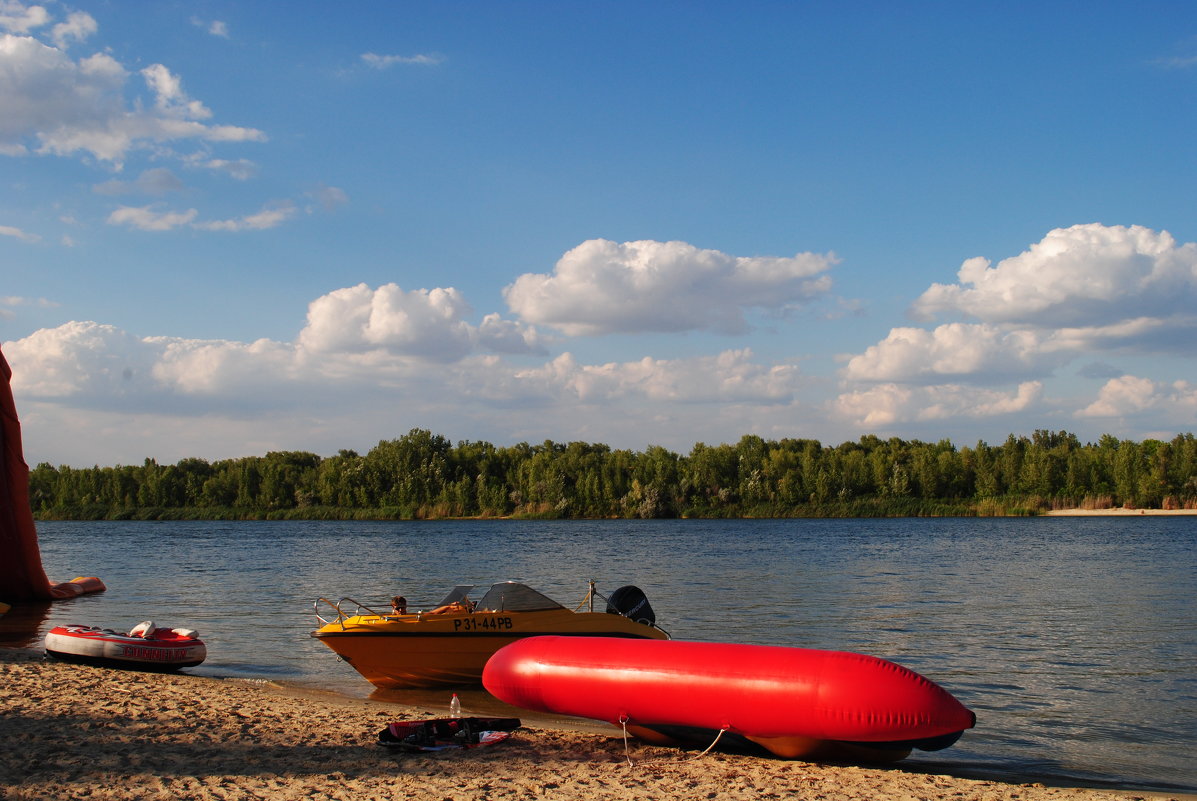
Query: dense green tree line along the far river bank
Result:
<box><xmin>30</xmin><ymin>429</ymin><xmax>1197</xmax><ymax>520</ymax></box>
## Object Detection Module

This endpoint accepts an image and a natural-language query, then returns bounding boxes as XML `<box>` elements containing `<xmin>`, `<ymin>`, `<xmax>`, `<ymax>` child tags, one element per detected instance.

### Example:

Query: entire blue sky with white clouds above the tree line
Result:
<box><xmin>0</xmin><ymin>0</ymin><xmax>1197</xmax><ymax>466</ymax></box>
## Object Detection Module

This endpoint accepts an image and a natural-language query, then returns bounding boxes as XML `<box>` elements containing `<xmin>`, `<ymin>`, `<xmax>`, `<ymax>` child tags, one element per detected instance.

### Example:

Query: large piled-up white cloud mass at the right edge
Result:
<box><xmin>837</xmin><ymin>223</ymin><xmax>1197</xmax><ymax>425</ymax></box>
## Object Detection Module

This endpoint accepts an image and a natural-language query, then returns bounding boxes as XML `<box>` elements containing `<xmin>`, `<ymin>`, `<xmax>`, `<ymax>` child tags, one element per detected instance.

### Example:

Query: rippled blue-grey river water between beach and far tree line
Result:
<box><xmin>0</xmin><ymin>517</ymin><xmax>1197</xmax><ymax>791</ymax></box>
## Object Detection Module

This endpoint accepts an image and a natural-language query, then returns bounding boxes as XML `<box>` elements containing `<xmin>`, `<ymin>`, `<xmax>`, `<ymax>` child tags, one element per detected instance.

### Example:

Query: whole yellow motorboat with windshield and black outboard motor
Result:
<box><xmin>311</xmin><ymin>582</ymin><xmax>669</xmax><ymax>690</ymax></box>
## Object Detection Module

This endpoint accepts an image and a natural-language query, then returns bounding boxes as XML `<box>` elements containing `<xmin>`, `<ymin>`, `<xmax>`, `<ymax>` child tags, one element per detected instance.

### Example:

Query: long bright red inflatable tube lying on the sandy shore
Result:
<box><xmin>482</xmin><ymin>637</ymin><xmax>977</xmax><ymax>761</ymax></box>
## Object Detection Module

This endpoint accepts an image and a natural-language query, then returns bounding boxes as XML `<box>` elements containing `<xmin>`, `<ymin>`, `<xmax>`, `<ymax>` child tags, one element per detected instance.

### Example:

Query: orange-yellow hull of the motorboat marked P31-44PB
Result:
<box><xmin>312</xmin><ymin>608</ymin><xmax>668</xmax><ymax>690</ymax></box>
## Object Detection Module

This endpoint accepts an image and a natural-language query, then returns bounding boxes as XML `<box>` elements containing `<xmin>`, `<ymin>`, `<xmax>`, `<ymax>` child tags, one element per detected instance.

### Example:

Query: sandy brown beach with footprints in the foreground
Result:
<box><xmin>0</xmin><ymin>649</ymin><xmax>1181</xmax><ymax>801</ymax></box>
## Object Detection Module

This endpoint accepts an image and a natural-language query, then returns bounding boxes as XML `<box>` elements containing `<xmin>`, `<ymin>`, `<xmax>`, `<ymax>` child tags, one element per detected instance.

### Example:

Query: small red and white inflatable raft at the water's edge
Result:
<box><xmin>45</xmin><ymin>620</ymin><xmax>208</xmax><ymax>670</ymax></box>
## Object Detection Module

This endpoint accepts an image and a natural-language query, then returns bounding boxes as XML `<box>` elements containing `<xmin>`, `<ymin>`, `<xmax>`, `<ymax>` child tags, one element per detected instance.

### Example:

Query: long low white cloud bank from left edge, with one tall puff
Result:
<box><xmin>5</xmin><ymin>311</ymin><xmax>798</xmax><ymax>442</ymax></box>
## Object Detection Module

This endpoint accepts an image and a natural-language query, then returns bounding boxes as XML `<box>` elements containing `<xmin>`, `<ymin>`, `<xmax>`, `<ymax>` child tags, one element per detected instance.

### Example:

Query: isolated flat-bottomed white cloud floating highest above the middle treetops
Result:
<box><xmin>503</xmin><ymin>239</ymin><xmax>837</xmax><ymax>336</ymax></box>
